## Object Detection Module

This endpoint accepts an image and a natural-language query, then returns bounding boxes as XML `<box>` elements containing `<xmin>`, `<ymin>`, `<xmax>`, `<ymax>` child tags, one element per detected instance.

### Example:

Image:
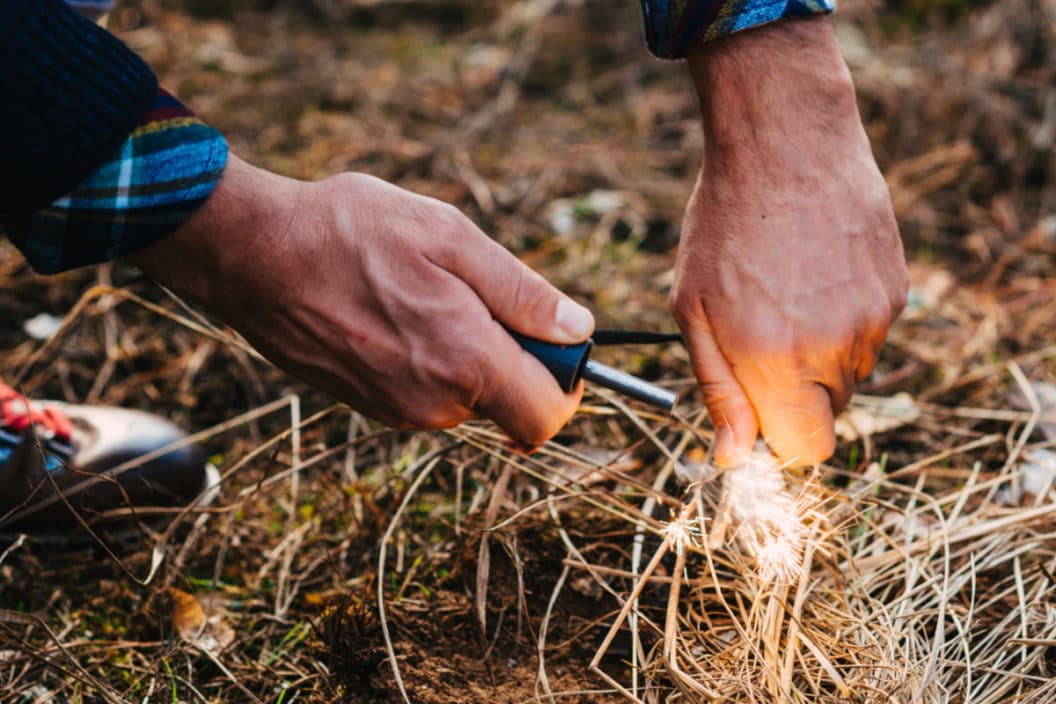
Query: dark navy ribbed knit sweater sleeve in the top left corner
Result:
<box><xmin>0</xmin><ymin>0</ymin><xmax>157</xmax><ymax>216</ymax></box>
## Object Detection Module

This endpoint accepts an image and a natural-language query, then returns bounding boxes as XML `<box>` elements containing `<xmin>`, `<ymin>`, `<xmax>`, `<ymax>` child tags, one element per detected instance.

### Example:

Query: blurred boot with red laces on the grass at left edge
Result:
<box><xmin>0</xmin><ymin>382</ymin><xmax>220</xmax><ymax>533</ymax></box>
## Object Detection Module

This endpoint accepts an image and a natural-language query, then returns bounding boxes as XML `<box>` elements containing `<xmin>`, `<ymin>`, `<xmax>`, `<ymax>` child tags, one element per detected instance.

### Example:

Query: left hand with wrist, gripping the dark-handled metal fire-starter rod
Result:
<box><xmin>133</xmin><ymin>155</ymin><xmax>593</xmax><ymax>445</ymax></box>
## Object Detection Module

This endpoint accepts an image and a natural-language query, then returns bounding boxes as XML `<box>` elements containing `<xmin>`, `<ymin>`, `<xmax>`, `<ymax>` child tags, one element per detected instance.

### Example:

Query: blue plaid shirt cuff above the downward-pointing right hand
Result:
<box><xmin>641</xmin><ymin>0</ymin><xmax>836</xmax><ymax>59</ymax></box>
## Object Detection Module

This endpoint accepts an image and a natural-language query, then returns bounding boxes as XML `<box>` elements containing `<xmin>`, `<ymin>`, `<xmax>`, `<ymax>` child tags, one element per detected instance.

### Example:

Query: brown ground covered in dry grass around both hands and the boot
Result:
<box><xmin>0</xmin><ymin>0</ymin><xmax>1056</xmax><ymax>704</ymax></box>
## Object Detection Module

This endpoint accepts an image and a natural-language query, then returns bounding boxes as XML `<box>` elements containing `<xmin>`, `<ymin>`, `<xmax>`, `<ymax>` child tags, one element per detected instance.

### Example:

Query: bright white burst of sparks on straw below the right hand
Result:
<box><xmin>719</xmin><ymin>450</ymin><xmax>814</xmax><ymax>582</ymax></box>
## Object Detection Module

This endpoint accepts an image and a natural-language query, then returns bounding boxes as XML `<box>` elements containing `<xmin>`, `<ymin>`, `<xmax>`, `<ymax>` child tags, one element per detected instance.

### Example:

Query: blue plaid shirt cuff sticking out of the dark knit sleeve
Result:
<box><xmin>4</xmin><ymin>90</ymin><xmax>227</xmax><ymax>273</ymax></box>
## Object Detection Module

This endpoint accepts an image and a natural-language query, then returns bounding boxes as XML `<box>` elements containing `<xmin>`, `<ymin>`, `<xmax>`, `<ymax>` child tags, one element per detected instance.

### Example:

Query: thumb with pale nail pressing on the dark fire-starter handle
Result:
<box><xmin>446</xmin><ymin>227</ymin><xmax>595</xmax><ymax>344</ymax></box>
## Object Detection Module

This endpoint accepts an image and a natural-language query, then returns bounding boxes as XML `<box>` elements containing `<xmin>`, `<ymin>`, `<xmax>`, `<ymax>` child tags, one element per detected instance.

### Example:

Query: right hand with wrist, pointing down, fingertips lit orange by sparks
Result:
<box><xmin>672</xmin><ymin>18</ymin><xmax>907</xmax><ymax>465</ymax></box>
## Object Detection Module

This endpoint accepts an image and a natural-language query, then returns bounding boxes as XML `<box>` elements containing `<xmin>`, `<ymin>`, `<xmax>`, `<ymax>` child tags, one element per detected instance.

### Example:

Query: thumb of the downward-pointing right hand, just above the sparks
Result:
<box><xmin>679</xmin><ymin>315</ymin><xmax>759</xmax><ymax>467</ymax></box>
